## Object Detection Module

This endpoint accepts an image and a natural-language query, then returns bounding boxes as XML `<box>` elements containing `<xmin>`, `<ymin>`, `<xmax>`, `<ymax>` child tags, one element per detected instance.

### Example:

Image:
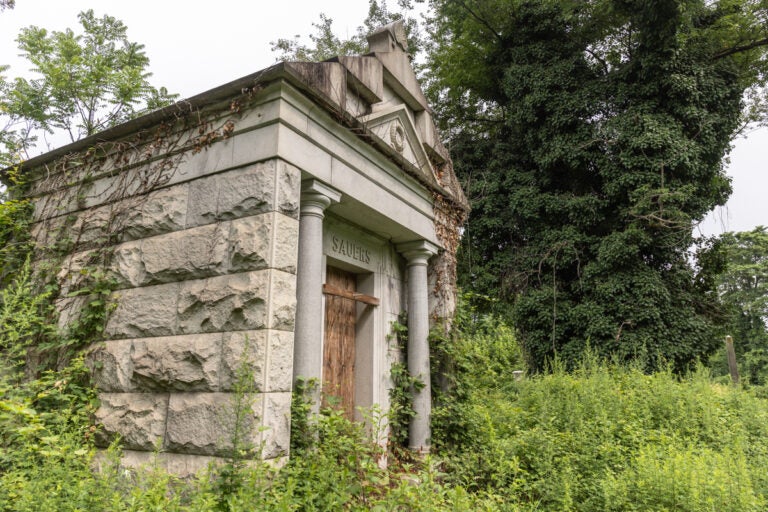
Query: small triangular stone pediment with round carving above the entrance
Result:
<box><xmin>360</xmin><ymin>104</ymin><xmax>440</xmax><ymax>186</ymax></box>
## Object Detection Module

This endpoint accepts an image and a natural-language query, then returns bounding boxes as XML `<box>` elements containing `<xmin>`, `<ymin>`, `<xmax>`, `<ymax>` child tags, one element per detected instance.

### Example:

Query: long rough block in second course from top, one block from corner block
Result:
<box><xmin>141</xmin><ymin>223</ymin><xmax>229</xmax><ymax>283</ymax></box>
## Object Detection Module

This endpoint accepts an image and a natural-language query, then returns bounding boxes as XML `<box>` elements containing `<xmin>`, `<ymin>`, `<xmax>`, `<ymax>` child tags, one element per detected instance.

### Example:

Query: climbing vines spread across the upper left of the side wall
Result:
<box><xmin>0</xmin><ymin>85</ymin><xmax>270</xmax><ymax>371</ymax></box>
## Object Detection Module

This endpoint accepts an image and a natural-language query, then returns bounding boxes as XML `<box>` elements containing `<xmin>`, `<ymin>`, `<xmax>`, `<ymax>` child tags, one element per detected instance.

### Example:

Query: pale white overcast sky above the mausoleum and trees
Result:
<box><xmin>0</xmin><ymin>0</ymin><xmax>768</xmax><ymax>234</ymax></box>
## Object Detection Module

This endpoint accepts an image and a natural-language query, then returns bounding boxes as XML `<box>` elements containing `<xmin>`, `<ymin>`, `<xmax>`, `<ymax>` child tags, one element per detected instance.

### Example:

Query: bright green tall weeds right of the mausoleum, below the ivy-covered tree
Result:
<box><xmin>438</xmin><ymin>338</ymin><xmax>768</xmax><ymax>512</ymax></box>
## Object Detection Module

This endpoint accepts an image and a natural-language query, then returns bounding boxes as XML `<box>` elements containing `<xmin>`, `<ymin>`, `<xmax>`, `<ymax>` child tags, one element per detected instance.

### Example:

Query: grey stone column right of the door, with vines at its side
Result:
<box><xmin>397</xmin><ymin>240</ymin><xmax>438</xmax><ymax>453</ymax></box>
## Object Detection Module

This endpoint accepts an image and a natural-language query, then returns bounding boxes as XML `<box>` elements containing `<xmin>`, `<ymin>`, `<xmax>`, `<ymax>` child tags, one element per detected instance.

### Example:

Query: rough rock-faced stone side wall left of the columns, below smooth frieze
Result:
<box><xmin>27</xmin><ymin>158</ymin><xmax>300</xmax><ymax>474</ymax></box>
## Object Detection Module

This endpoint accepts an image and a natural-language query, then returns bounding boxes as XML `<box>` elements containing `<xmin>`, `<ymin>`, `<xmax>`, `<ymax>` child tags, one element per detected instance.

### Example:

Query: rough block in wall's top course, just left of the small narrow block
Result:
<box><xmin>122</xmin><ymin>184</ymin><xmax>190</xmax><ymax>239</ymax></box>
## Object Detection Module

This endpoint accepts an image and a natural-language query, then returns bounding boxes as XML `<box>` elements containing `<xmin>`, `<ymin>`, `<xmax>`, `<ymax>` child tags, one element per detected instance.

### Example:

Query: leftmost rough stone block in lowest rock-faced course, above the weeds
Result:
<box><xmin>96</xmin><ymin>393</ymin><xmax>168</xmax><ymax>451</ymax></box>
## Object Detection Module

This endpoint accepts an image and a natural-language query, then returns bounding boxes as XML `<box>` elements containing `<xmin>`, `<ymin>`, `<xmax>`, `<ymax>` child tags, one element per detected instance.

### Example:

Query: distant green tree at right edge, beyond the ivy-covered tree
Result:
<box><xmin>717</xmin><ymin>226</ymin><xmax>768</xmax><ymax>384</ymax></box>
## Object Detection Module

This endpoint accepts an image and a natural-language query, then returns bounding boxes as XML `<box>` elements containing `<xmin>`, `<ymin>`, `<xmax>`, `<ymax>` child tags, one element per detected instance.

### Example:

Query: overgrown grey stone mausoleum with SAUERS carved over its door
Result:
<box><xmin>23</xmin><ymin>24</ymin><xmax>467</xmax><ymax>474</ymax></box>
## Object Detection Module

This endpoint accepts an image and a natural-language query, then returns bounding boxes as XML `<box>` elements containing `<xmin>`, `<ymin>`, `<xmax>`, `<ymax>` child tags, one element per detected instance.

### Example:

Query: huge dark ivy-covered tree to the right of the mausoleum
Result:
<box><xmin>428</xmin><ymin>0</ymin><xmax>768</xmax><ymax>370</ymax></box>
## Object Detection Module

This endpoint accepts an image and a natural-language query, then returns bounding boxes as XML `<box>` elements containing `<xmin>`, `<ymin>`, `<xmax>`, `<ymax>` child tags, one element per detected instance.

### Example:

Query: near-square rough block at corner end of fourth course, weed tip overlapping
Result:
<box><xmin>219</xmin><ymin>330</ymin><xmax>268</xmax><ymax>391</ymax></box>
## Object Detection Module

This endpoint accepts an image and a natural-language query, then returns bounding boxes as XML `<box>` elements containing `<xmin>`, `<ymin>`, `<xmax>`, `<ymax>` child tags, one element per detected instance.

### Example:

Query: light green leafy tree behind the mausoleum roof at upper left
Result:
<box><xmin>0</xmin><ymin>10</ymin><xmax>176</xmax><ymax>167</ymax></box>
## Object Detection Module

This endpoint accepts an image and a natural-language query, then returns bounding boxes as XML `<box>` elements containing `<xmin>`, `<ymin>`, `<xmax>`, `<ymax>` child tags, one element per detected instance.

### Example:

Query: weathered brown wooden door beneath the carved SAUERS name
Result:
<box><xmin>323</xmin><ymin>267</ymin><xmax>357</xmax><ymax>419</ymax></box>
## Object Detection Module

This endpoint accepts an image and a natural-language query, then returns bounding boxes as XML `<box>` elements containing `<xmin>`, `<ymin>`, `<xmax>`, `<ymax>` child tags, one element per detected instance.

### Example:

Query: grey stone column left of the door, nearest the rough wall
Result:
<box><xmin>293</xmin><ymin>179</ymin><xmax>341</xmax><ymax>391</ymax></box>
